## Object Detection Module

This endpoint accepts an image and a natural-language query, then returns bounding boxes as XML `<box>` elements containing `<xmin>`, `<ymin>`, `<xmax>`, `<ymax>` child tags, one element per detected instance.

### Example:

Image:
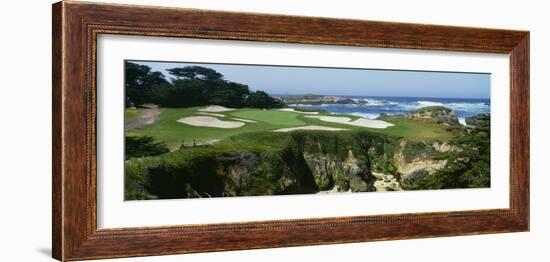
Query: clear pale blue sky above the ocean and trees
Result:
<box><xmin>134</xmin><ymin>61</ymin><xmax>491</xmax><ymax>98</ymax></box>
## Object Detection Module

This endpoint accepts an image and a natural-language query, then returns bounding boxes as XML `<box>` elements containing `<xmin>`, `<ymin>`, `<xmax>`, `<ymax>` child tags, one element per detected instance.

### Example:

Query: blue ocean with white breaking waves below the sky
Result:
<box><xmin>289</xmin><ymin>96</ymin><xmax>491</xmax><ymax>124</ymax></box>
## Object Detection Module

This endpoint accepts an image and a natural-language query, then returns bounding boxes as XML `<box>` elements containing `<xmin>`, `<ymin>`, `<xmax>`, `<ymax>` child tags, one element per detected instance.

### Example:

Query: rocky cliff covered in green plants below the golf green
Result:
<box><xmin>126</xmin><ymin>132</ymin><xmax>460</xmax><ymax>199</ymax></box>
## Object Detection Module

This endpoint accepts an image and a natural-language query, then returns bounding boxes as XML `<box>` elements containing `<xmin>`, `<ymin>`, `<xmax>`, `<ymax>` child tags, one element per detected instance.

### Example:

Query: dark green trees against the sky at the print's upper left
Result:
<box><xmin>124</xmin><ymin>61</ymin><xmax>285</xmax><ymax>108</ymax></box>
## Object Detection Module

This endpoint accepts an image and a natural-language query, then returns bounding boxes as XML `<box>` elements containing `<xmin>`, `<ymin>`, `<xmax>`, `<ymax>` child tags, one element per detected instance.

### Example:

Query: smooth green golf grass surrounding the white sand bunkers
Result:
<box><xmin>125</xmin><ymin>107</ymin><xmax>458</xmax><ymax>150</ymax></box>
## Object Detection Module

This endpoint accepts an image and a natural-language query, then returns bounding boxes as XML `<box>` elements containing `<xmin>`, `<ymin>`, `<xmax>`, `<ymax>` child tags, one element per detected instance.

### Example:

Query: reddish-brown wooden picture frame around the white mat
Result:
<box><xmin>52</xmin><ymin>2</ymin><xmax>529</xmax><ymax>261</ymax></box>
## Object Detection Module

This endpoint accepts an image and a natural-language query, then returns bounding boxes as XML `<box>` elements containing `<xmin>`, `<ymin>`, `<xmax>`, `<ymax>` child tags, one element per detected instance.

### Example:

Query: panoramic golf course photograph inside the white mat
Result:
<box><xmin>124</xmin><ymin>60</ymin><xmax>491</xmax><ymax>200</ymax></box>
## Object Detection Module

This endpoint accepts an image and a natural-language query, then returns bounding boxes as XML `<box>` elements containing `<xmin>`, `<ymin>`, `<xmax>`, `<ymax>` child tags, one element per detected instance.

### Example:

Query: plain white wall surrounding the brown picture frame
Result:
<box><xmin>0</xmin><ymin>0</ymin><xmax>550</xmax><ymax>262</ymax></box>
